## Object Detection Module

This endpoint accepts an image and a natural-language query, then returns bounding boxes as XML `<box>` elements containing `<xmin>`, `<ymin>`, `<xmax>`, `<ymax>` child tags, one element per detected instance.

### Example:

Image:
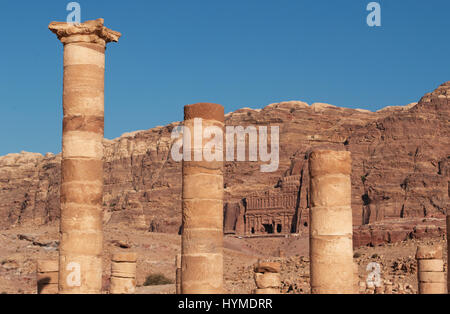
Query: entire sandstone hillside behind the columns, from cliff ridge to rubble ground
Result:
<box><xmin>0</xmin><ymin>82</ymin><xmax>450</xmax><ymax>293</ymax></box>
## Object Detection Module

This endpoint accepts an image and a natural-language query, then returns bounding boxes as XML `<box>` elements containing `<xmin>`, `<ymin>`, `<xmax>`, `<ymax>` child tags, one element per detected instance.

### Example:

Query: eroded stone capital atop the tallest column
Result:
<box><xmin>48</xmin><ymin>19</ymin><xmax>122</xmax><ymax>46</ymax></box>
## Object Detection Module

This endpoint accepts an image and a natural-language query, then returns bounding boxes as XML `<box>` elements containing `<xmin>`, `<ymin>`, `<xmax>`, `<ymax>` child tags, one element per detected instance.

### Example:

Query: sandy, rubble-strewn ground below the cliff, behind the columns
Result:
<box><xmin>0</xmin><ymin>225</ymin><xmax>446</xmax><ymax>294</ymax></box>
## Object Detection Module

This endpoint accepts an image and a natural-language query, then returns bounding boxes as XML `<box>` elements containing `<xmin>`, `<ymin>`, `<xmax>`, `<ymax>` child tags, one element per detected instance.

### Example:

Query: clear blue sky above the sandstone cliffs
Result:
<box><xmin>0</xmin><ymin>0</ymin><xmax>450</xmax><ymax>155</ymax></box>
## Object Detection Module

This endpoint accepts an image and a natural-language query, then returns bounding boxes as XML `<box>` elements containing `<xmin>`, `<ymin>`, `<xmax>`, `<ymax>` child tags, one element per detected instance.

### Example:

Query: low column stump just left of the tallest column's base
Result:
<box><xmin>36</xmin><ymin>260</ymin><xmax>58</xmax><ymax>294</ymax></box>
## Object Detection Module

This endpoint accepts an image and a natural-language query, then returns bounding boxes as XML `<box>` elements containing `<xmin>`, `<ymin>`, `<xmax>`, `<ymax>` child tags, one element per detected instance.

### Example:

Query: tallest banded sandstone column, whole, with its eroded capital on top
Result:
<box><xmin>49</xmin><ymin>19</ymin><xmax>121</xmax><ymax>294</ymax></box>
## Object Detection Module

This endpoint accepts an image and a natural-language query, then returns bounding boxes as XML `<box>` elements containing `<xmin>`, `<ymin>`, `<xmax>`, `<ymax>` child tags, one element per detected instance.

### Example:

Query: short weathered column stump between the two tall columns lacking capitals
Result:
<box><xmin>254</xmin><ymin>261</ymin><xmax>281</xmax><ymax>294</ymax></box>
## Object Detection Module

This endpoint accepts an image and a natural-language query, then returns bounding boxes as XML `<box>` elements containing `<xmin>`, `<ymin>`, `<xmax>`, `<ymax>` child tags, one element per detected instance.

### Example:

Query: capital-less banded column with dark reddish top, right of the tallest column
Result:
<box><xmin>181</xmin><ymin>103</ymin><xmax>224</xmax><ymax>294</ymax></box>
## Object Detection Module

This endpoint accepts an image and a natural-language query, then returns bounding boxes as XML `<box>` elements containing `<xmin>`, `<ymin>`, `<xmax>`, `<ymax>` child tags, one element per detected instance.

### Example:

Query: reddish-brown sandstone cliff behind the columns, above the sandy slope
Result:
<box><xmin>0</xmin><ymin>82</ymin><xmax>450</xmax><ymax>245</ymax></box>
